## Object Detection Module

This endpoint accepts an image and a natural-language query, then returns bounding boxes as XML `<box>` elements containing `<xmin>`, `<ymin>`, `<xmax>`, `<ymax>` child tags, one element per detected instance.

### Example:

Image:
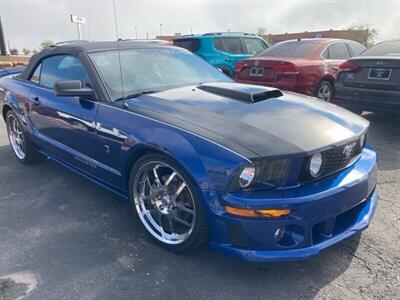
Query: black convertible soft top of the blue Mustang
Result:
<box><xmin>19</xmin><ymin>40</ymin><xmax>167</xmax><ymax>80</ymax></box>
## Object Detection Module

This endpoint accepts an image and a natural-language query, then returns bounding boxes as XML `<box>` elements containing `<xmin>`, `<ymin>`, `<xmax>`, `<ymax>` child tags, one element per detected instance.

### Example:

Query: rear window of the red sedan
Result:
<box><xmin>259</xmin><ymin>41</ymin><xmax>318</xmax><ymax>58</ymax></box>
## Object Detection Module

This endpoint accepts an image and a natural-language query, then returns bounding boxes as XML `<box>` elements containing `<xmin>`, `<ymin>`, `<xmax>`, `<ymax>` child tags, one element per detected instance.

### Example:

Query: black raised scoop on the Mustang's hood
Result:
<box><xmin>197</xmin><ymin>82</ymin><xmax>283</xmax><ymax>103</ymax></box>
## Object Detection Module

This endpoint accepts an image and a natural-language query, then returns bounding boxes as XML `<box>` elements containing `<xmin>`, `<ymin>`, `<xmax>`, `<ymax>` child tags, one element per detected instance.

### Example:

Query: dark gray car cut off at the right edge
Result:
<box><xmin>332</xmin><ymin>40</ymin><xmax>400</xmax><ymax>113</ymax></box>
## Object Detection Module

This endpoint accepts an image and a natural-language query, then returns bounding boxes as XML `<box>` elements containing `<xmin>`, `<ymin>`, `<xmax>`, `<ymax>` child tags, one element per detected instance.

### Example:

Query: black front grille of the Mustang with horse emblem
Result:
<box><xmin>300</xmin><ymin>140</ymin><xmax>362</xmax><ymax>182</ymax></box>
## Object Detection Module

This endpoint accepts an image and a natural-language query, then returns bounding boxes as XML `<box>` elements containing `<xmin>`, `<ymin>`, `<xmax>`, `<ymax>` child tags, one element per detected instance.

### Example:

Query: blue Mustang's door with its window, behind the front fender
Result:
<box><xmin>29</xmin><ymin>55</ymin><xmax>98</xmax><ymax>171</ymax></box>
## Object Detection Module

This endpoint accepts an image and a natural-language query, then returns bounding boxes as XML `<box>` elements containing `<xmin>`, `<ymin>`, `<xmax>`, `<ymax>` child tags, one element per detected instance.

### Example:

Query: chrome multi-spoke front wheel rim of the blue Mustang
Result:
<box><xmin>133</xmin><ymin>161</ymin><xmax>196</xmax><ymax>245</ymax></box>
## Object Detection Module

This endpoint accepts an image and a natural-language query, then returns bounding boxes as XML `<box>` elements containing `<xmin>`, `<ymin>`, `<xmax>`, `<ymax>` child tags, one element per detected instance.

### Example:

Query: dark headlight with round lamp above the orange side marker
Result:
<box><xmin>229</xmin><ymin>159</ymin><xmax>289</xmax><ymax>191</ymax></box>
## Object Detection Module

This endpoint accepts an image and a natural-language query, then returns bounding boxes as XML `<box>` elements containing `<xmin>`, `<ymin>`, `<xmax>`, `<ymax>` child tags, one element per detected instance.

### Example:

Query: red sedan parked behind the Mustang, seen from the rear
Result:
<box><xmin>235</xmin><ymin>38</ymin><xmax>365</xmax><ymax>101</ymax></box>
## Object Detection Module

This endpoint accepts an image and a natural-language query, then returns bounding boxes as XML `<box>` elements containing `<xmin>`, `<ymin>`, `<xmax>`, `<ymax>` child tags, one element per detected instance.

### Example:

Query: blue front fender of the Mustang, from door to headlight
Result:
<box><xmin>97</xmin><ymin>105</ymin><xmax>246</xmax><ymax>191</ymax></box>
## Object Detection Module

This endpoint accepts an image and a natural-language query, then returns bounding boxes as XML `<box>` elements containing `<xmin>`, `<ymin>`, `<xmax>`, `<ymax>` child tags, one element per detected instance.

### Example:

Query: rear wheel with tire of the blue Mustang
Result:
<box><xmin>6</xmin><ymin>110</ymin><xmax>38</xmax><ymax>164</ymax></box>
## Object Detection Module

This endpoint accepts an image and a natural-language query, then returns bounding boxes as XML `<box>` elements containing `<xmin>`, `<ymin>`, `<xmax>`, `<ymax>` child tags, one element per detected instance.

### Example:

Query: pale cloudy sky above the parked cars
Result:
<box><xmin>0</xmin><ymin>0</ymin><xmax>400</xmax><ymax>49</ymax></box>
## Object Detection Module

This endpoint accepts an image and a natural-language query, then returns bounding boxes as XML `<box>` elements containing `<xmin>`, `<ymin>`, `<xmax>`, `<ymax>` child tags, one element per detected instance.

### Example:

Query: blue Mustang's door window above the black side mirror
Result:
<box><xmin>39</xmin><ymin>55</ymin><xmax>90</xmax><ymax>89</ymax></box>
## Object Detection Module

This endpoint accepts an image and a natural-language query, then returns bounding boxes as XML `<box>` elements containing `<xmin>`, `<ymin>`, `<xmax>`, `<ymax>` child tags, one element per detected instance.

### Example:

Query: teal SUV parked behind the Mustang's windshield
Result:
<box><xmin>174</xmin><ymin>32</ymin><xmax>268</xmax><ymax>77</ymax></box>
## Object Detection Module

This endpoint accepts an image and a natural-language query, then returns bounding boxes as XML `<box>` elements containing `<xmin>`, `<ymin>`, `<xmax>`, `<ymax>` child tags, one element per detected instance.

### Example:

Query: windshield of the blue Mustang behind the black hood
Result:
<box><xmin>89</xmin><ymin>47</ymin><xmax>232</xmax><ymax>100</ymax></box>
